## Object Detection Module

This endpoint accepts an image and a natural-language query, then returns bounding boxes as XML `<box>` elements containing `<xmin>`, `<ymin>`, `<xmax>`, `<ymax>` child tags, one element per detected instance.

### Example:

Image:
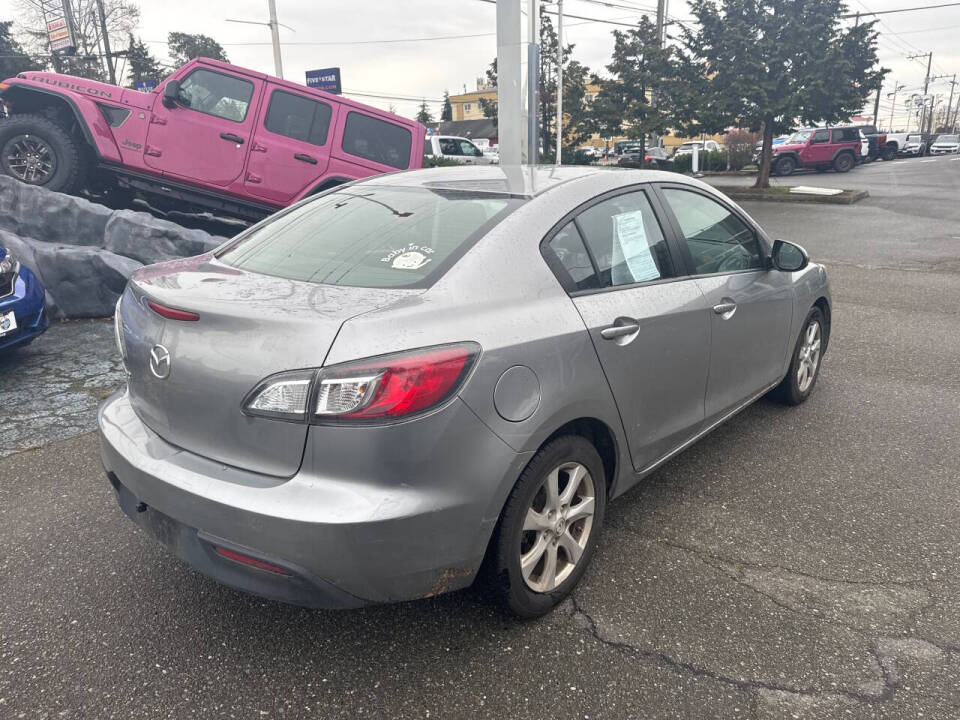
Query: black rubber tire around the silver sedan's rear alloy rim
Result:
<box><xmin>483</xmin><ymin>435</ymin><xmax>607</xmax><ymax>618</ymax></box>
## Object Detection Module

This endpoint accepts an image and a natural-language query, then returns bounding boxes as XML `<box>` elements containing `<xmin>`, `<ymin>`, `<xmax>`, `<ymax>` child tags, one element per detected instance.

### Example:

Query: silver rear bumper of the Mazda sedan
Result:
<box><xmin>99</xmin><ymin>391</ymin><xmax>529</xmax><ymax>608</ymax></box>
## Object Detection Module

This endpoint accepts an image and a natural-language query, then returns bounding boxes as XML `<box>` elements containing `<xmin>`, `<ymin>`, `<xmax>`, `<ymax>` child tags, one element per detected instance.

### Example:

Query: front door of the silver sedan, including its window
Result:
<box><xmin>660</xmin><ymin>184</ymin><xmax>794</xmax><ymax>423</ymax></box>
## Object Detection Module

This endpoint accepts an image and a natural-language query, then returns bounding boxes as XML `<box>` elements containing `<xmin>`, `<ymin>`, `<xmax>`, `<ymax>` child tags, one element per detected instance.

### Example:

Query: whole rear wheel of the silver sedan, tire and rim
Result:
<box><xmin>488</xmin><ymin>435</ymin><xmax>607</xmax><ymax>618</ymax></box>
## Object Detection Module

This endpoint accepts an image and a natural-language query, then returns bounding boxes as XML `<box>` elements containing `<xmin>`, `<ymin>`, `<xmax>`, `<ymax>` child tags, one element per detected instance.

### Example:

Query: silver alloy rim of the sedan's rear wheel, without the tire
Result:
<box><xmin>520</xmin><ymin>462</ymin><xmax>596</xmax><ymax>593</ymax></box>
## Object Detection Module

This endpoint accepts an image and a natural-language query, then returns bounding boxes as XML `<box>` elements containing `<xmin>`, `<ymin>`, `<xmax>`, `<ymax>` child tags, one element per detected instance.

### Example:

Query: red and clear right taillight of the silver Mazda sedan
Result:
<box><xmin>243</xmin><ymin>343</ymin><xmax>480</xmax><ymax>424</ymax></box>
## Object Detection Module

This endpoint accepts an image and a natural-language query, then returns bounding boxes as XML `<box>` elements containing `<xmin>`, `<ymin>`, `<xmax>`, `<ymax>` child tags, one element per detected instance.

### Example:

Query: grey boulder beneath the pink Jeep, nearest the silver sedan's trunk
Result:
<box><xmin>102</xmin><ymin>210</ymin><xmax>225</xmax><ymax>265</ymax></box>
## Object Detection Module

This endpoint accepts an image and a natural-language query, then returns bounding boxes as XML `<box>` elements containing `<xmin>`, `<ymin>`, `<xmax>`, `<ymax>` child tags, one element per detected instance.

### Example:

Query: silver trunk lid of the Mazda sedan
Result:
<box><xmin>121</xmin><ymin>255</ymin><xmax>423</xmax><ymax>477</ymax></box>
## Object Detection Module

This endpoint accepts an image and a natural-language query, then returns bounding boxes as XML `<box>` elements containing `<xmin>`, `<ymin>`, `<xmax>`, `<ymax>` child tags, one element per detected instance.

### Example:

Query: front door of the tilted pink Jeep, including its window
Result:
<box><xmin>144</xmin><ymin>65</ymin><xmax>263</xmax><ymax>187</ymax></box>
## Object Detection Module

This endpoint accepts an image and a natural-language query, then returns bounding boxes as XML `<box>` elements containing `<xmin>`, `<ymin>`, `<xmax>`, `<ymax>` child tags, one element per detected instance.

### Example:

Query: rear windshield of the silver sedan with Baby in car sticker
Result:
<box><xmin>220</xmin><ymin>185</ymin><xmax>524</xmax><ymax>288</ymax></box>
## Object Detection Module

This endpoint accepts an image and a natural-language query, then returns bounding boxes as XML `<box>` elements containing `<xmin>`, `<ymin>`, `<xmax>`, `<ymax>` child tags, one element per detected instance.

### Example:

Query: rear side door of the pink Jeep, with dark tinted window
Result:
<box><xmin>243</xmin><ymin>83</ymin><xmax>339</xmax><ymax>205</ymax></box>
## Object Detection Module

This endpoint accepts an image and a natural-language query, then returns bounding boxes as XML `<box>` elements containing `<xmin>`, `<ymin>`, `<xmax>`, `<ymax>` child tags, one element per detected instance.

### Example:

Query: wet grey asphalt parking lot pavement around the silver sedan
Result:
<box><xmin>0</xmin><ymin>157</ymin><xmax>960</xmax><ymax>720</ymax></box>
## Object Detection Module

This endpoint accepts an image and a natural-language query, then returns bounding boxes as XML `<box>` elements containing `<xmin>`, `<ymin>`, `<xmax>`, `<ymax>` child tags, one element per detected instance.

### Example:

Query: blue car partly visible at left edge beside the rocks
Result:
<box><xmin>0</xmin><ymin>247</ymin><xmax>50</xmax><ymax>350</ymax></box>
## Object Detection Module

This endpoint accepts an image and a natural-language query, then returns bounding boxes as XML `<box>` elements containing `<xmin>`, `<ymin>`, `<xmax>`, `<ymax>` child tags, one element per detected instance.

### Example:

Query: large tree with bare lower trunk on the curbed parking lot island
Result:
<box><xmin>684</xmin><ymin>0</ymin><xmax>886</xmax><ymax>188</ymax></box>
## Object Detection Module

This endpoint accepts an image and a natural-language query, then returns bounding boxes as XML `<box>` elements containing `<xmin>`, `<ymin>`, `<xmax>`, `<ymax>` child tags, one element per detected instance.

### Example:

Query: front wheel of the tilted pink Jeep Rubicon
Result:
<box><xmin>0</xmin><ymin>115</ymin><xmax>81</xmax><ymax>192</ymax></box>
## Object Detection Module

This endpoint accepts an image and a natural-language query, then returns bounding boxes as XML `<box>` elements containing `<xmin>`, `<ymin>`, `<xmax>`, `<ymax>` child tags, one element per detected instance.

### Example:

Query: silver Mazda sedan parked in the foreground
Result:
<box><xmin>100</xmin><ymin>167</ymin><xmax>831</xmax><ymax>617</ymax></box>
